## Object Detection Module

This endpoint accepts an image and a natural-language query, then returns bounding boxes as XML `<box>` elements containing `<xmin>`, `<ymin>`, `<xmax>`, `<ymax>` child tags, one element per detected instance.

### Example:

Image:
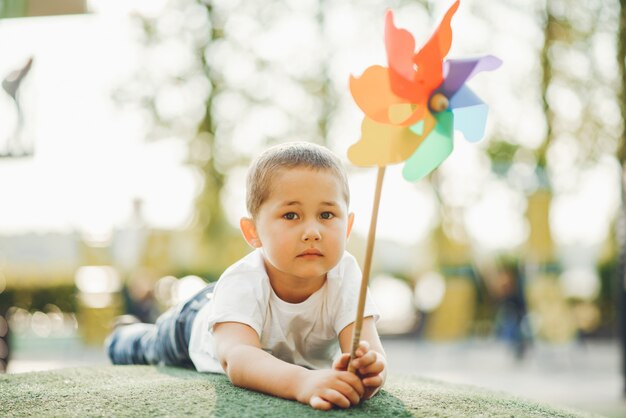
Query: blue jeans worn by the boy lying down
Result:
<box><xmin>105</xmin><ymin>283</ymin><xmax>215</xmax><ymax>368</ymax></box>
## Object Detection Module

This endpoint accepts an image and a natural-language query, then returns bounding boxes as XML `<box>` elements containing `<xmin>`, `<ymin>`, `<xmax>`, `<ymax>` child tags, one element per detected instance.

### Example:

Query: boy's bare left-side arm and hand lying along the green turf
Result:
<box><xmin>213</xmin><ymin>322</ymin><xmax>365</xmax><ymax>409</ymax></box>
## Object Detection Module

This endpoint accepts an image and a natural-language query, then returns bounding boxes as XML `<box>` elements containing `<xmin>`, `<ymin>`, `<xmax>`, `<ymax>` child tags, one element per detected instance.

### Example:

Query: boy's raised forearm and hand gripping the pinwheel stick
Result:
<box><xmin>339</xmin><ymin>316</ymin><xmax>387</xmax><ymax>399</ymax></box>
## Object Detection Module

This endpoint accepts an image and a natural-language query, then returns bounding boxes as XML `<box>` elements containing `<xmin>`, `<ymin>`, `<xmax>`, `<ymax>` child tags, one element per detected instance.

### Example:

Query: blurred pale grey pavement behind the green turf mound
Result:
<box><xmin>8</xmin><ymin>336</ymin><xmax>626</xmax><ymax>418</ymax></box>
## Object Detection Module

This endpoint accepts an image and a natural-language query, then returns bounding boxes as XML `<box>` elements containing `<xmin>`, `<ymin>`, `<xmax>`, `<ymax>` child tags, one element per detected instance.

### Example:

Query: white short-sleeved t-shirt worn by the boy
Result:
<box><xmin>189</xmin><ymin>249</ymin><xmax>379</xmax><ymax>373</ymax></box>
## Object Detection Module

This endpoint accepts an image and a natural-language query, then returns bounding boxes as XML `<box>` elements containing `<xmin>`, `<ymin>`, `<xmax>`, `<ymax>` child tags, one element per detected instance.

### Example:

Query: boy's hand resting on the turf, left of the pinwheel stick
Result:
<box><xmin>296</xmin><ymin>370</ymin><xmax>365</xmax><ymax>410</ymax></box>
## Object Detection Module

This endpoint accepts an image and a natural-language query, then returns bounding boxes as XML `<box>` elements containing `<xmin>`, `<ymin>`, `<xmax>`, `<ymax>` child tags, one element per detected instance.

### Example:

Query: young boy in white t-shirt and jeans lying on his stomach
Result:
<box><xmin>107</xmin><ymin>143</ymin><xmax>386</xmax><ymax>409</ymax></box>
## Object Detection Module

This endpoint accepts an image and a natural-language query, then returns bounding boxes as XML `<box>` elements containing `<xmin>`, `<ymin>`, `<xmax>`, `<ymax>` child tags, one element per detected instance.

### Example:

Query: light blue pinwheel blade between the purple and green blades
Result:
<box><xmin>450</xmin><ymin>86</ymin><xmax>489</xmax><ymax>142</ymax></box>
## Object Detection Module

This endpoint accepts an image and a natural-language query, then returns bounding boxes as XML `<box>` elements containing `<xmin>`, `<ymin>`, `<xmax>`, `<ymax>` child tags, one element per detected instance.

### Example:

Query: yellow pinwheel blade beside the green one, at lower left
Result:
<box><xmin>348</xmin><ymin>112</ymin><xmax>436</xmax><ymax>167</ymax></box>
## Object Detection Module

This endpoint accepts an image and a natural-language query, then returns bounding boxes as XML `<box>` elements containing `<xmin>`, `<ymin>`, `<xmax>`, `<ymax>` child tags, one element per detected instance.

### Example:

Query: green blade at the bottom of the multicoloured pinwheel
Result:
<box><xmin>402</xmin><ymin>110</ymin><xmax>454</xmax><ymax>181</ymax></box>
